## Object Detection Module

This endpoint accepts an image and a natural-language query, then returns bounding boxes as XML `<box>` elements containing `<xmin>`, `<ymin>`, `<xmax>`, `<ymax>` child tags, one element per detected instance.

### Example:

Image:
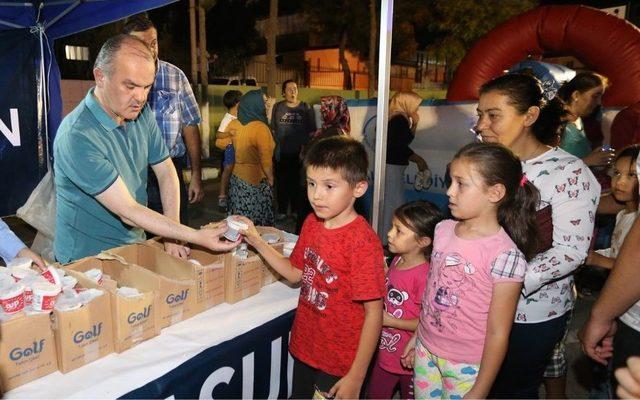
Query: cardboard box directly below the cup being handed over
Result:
<box><xmin>224</xmin><ymin>250</ymin><xmax>264</xmax><ymax>304</ymax></box>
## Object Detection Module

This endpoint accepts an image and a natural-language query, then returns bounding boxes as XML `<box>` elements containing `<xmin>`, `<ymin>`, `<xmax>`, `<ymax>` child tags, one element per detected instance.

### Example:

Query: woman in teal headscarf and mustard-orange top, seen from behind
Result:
<box><xmin>227</xmin><ymin>89</ymin><xmax>275</xmax><ymax>226</ymax></box>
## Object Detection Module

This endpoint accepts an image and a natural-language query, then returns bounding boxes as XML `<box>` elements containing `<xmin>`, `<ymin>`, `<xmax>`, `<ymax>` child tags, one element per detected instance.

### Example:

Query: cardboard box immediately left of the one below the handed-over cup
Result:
<box><xmin>146</xmin><ymin>237</ymin><xmax>224</xmax><ymax>311</ymax></box>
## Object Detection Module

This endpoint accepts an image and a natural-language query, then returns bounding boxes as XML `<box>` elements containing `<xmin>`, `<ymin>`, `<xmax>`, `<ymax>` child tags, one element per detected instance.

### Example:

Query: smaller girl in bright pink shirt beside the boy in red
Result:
<box><xmin>367</xmin><ymin>201</ymin><xmax>442</xmax><ymax>399</ymax></box>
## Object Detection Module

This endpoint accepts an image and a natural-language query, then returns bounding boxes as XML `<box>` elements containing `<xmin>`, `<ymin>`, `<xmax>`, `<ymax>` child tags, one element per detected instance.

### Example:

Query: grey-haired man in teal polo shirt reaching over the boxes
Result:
<box><xmin>54</xmin><ymin>35</ymin><xmax>237</xmax><ymax>263</ymax></box>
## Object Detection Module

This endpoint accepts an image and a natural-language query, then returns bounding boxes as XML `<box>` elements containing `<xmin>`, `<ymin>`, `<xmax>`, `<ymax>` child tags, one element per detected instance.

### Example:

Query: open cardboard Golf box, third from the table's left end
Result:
<box><xmin>64</xmin><ymin>254</ymin><xmax>160</xmax><ymax>353</ymax></box>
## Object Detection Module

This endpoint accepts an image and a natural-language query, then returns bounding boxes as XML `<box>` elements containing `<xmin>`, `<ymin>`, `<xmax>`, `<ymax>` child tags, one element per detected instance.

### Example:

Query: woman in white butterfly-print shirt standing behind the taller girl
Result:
<box><xmin>476</xmin><ymin>74</ymin><xmax>600</xmax><ymax>398</ymax></box>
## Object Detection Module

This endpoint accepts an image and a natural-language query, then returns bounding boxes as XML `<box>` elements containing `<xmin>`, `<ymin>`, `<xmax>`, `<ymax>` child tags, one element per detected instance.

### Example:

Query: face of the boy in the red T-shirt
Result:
<box><xmin>307</xmin><ymin>166</ymin><xmax>367</xmax><ymax>227</ymax></box>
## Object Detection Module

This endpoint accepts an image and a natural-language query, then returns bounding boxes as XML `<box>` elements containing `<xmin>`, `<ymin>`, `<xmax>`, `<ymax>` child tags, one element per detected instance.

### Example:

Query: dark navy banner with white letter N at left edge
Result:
<box><xmin>0</xmin><ymin>29</ymin><xmax>47</xmax><ymax>216</ymax></box>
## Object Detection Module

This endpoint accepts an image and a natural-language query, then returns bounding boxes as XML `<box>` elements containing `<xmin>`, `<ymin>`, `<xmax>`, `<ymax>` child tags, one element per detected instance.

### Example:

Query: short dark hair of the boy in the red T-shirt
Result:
<box><xmin>303</xmin><ymin>136</ymin><xmax>368</xmax><ymax>186</ymax></box>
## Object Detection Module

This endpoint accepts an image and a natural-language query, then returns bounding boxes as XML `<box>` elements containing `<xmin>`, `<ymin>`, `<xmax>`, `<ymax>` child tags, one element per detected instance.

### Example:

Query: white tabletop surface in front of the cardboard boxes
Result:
<box><xmin>4</xmin><ymin>282</ymin><xmax>299</xmax><ymax>399</ymax></box>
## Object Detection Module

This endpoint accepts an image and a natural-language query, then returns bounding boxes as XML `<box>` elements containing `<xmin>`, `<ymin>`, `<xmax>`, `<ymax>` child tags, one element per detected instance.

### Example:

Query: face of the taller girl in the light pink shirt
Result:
<box><xmin>447</xmin><ymin>158</ymin><xmax>495</xmax><ymax>220</ymax></box>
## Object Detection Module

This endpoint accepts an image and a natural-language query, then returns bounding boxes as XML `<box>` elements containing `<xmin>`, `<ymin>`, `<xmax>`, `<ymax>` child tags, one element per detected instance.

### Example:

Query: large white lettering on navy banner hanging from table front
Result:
<box><xmin>199</xmin><ymin>337</ymin><xmax>293</xmax><ymax>400</ymax></box>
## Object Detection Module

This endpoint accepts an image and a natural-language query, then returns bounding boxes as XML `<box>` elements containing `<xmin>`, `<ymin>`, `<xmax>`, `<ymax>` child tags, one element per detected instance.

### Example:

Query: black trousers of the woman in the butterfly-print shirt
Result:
<box><xmin>488</xmin><ymin>312</ymin><xmax>570</xmax><ymax>399</ymax></box>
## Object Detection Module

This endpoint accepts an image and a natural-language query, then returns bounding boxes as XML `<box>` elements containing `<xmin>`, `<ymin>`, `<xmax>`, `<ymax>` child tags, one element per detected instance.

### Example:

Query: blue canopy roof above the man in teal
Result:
<box><xmin>0</xmin><ymin>0</ymin><xmax>177</xmax><ymax>39</ymax></box>
